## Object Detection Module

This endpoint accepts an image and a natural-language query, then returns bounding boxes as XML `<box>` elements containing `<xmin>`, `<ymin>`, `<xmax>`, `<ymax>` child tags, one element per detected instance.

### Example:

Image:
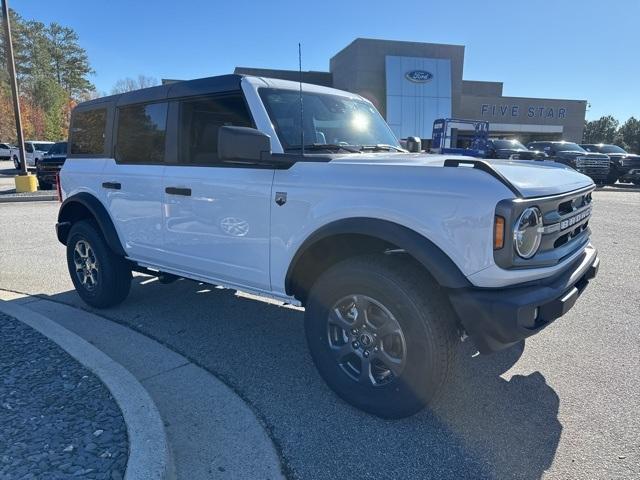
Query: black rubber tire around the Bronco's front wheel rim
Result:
<box><xmin>305</xmin><ymin>255</ymin><xmax>459</xmax><ymax>418</ymax></box>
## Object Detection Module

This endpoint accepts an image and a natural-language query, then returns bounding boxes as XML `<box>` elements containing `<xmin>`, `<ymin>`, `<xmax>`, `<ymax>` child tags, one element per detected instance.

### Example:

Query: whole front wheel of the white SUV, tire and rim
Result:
<box><xmin>305</xmin><ymin>255</ymin><xmax>458</xmax><ymax>418</ymax></box>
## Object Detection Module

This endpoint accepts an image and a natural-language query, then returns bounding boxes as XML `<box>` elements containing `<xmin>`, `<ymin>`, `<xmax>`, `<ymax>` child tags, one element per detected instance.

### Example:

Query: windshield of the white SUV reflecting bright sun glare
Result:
<box><xmin>260</xmin><ymin>88</ymin><xmax>400</xmax><ymax>151</ymax></box>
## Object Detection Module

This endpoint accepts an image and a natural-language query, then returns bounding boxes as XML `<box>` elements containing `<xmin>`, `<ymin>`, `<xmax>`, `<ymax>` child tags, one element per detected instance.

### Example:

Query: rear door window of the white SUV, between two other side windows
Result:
<box><xmin>116</xmin><ymin>103</ymin><xmax>167</xmax><ymax>163</ymax></box>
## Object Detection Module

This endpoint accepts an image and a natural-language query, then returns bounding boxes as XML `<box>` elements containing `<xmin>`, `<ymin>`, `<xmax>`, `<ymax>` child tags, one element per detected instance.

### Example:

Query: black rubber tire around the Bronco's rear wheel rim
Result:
<box><xmin>67</xmin><ymin>220</ymin><xmax>131</xmax><ymax>308</ymax></box>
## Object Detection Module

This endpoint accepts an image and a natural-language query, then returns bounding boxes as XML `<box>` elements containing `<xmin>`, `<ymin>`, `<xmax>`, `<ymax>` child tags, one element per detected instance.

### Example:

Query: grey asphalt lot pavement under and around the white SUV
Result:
<box><xmin>0</xmin><ymin>187</ymin><xmax>640</xmax><ymax>479</ymax></box>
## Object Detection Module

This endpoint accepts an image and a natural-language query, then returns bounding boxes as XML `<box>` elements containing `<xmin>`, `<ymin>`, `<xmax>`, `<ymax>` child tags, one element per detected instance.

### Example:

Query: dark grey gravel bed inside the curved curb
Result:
<box><xmin>0</xmin><ymin>313</ymin><xmax>128</xmax><ymax>480</ymax></box>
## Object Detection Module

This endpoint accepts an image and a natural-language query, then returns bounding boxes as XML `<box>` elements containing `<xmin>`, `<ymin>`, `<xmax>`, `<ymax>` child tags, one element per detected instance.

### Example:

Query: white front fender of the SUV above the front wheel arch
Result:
<box><xmin>271</xmin><ymin>161</ymin><xmax>513</xmax><ymax>293</ymax></box>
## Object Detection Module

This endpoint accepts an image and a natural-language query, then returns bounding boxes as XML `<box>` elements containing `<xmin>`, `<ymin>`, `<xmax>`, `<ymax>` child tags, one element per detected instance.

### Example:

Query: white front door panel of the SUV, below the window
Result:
<box><xmin>161</xmin><ymin>166</ymin><xmax>273</xmax><ymax>290</ymax></box>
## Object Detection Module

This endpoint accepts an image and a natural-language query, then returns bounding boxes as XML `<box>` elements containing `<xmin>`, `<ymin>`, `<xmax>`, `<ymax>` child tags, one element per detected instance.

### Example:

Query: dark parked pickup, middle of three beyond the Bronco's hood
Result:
<box><xmin>527</xmin><ymin>142</ymin><xmax>610</xmax><ymax>184</ymax></box>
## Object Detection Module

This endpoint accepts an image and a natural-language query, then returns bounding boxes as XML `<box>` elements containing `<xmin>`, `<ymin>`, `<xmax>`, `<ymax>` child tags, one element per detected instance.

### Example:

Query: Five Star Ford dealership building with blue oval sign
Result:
<box><xmin>235</xmin><ymin>38</ymin><xmax>587</xmax><ymax>142</ymax></box>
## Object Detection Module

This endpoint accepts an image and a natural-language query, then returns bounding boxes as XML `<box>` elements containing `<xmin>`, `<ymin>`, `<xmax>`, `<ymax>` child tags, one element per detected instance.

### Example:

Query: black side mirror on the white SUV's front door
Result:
<box><xmin>218</xmin><ymin>126</ymin><xmax>271</xmax><ymax>162</ymax></box>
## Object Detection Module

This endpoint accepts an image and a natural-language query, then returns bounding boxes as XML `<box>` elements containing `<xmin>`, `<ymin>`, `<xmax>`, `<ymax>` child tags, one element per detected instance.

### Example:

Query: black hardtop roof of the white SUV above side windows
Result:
<box><xmin>76</xmin><ymin>74</ymin><xmax>243</xmax><ymax>109</ymax></box>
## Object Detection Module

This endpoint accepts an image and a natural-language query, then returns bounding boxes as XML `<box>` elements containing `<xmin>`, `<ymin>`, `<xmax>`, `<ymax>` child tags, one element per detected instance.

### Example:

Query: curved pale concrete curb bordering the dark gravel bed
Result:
<box><xmin>0</xmin><ymin>300</ymin><xmax>175</xmax><ymax>480</ymax></box>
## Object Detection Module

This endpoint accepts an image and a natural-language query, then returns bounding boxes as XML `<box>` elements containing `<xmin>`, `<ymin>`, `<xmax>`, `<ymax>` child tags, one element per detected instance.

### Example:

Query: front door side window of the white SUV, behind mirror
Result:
<box><xmin>179</xmin><ymin>94</ymin><xmax>253</xmax><ymax>165</ymax></box>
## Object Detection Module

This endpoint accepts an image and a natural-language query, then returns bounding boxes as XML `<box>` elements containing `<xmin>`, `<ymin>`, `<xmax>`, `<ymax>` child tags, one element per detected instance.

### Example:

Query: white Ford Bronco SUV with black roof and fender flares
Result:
<box><xmin>56</xmin><ymin>75</ymin><xmax>599</xmax><ymax>417</ymax></box>
